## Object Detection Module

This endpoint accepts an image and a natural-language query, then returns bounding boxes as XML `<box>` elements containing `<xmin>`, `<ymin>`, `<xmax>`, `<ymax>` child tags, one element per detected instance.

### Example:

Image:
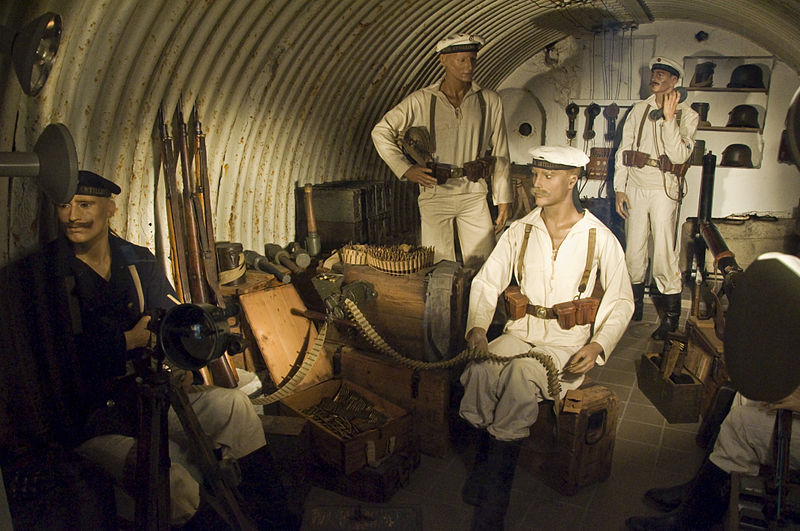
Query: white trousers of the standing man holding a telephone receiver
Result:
<box><xmin>625</xmin><ymin>186</ymin><xmax>682</xmax><ymax>295</ymax></box>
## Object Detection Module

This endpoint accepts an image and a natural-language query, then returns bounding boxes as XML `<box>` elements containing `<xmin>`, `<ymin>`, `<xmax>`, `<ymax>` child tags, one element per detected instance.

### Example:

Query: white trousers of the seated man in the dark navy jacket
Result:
<box><xmin>76</xmin><ymin>386</ymin><xmax>266</xmax><ymax>525</ymax></box>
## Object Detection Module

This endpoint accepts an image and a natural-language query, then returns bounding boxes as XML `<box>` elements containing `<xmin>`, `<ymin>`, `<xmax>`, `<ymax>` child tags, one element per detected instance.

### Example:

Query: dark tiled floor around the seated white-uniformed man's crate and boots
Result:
<box><xmin>296</xmin><ymin>300</ymin><xmax>704</xmax><ymax>531</ymax></box>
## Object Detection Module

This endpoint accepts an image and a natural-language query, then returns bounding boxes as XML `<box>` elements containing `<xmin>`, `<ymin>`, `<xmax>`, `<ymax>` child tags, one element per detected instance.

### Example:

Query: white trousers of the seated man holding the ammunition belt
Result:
<box><xmin>459</xmin><ymin>334</ymin><xmax>582</xmax><ymax>441</ymax></box>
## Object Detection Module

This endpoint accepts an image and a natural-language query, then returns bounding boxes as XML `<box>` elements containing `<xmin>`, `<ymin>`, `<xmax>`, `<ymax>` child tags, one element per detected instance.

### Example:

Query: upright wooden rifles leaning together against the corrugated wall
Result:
<box><xmin>158</xmin><ymin>101</ymin><xmax>238</xmax><ymax>388</ymax></box>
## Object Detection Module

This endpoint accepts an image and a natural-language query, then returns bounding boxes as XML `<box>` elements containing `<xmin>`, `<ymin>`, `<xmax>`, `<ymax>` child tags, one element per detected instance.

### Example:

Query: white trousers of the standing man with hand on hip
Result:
<box><xmin>417</xmin><ymin>187</ymin><xmax>495</xmax><ymax>266</ymax></box>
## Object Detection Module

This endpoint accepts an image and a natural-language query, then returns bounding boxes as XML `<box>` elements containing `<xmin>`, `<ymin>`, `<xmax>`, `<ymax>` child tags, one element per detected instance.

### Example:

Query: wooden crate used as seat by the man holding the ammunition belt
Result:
<box><xmin>519</xmin><ymin>384</ymin><xmax>619</xmax><ymax>496</ymax></box>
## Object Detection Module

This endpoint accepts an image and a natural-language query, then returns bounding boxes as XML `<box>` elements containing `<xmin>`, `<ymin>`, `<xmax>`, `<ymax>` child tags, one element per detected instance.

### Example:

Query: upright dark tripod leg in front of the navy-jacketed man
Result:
<box><xmin>135</xmin><ymin>374</ymin><xmax>170</xmax><ymax>531</ymax></box>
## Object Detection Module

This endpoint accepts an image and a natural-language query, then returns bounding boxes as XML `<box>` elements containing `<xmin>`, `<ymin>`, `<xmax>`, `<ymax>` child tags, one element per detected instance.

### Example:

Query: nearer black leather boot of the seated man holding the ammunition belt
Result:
<box><xmin>472</xmin><ymin>436</ymin><xmax>522</xmax><ymax>531</ymax></box>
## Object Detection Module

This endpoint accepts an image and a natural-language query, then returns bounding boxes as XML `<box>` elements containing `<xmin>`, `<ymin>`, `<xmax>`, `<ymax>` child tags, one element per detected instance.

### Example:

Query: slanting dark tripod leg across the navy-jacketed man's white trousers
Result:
<box><xmin>169</xmin><ymin>385</ymin><xmax>256</xmax><ymax>530</ymax></box>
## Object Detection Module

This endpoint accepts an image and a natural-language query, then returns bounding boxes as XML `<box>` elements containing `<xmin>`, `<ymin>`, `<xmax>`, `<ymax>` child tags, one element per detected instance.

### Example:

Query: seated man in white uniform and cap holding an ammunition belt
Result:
<box><xmin>460</xmin><ymin>146</ymin><xmax>633</xmax><ymax>530</ymax></box>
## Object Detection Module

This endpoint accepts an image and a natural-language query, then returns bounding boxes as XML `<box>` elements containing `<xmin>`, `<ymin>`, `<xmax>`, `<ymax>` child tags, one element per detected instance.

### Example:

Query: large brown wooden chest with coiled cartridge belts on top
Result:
<box><xmin>344</xmin><ymin>264</ymin><xmax>475</xmax><ymax>360</ymax></box>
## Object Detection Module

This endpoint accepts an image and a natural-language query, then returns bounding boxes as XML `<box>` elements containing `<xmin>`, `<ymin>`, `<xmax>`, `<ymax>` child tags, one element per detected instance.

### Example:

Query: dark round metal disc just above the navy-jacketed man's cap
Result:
<box><xmin>33</xmin><ymin>124</ymin><xmax>78</xmax><ymax>203</ymax></box>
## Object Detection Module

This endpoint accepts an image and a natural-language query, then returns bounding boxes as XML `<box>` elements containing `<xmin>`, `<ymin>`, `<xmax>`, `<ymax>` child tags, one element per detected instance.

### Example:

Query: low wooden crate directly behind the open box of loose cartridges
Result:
<box><xmin>340</xmin><ymin>346</ymin><xmax>460</xmax><ymax>457</ymax></box>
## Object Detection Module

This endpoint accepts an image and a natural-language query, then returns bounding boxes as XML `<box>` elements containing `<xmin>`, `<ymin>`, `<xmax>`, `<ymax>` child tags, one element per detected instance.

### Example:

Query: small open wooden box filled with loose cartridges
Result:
<box><xmin>280</xmin><ymin>378</ymin><xmax>413</xmax><ymax>474</ymax></box>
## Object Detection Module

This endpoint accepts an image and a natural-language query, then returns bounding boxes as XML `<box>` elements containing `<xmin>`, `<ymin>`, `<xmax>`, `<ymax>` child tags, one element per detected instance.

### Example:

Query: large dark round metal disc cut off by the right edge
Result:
<box><xmin>724</xmin><ymin>253</ymin><xmax>800</xmax><ymax>402</ymax></box>
